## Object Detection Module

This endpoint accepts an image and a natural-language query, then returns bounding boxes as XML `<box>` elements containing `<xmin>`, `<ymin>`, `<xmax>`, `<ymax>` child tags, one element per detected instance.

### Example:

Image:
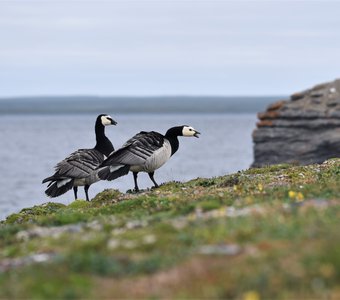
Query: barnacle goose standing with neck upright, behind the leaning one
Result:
<box><xmin>42</xmin><ymin>114</ymin><xmax>124</xmax><ymax>201</ymax></box>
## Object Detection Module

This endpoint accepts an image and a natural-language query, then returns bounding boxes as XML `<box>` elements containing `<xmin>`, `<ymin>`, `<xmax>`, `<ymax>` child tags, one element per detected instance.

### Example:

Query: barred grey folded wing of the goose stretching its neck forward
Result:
<box><xmin>101</xmin><ymin>131</ymin><xmax>164</xmax><ymax>166</ymax></box>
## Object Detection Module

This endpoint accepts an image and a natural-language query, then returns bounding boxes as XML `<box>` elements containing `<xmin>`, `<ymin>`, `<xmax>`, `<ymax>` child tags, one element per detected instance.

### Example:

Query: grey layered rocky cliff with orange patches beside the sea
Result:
<box><xmin>253</xmin><ymin>79</ymin><xmax>340</xmax><ymax>167</ymax></box>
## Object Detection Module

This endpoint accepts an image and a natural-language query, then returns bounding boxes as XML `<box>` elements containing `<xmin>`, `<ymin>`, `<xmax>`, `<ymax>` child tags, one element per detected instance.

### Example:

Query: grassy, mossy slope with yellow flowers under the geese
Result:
<box><xmin>0</xmin><ymin>159</ymin><xmax>340</xmax><ymax>300</ymax></box>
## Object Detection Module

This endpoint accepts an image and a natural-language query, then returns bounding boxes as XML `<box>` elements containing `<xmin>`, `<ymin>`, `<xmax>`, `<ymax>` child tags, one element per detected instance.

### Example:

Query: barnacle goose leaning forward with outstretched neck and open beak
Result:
<box><xmin>98</xmin><ymin>125</ymin><xmax>200</xmax><ymax>191</ymax></box>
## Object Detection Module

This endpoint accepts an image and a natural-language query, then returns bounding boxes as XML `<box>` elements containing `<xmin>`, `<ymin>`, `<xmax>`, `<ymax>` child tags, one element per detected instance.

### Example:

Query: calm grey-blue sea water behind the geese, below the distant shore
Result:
<box><xmin>0</xmin><ymin>112</ymin><xmax>256</xmax><ymax>219</ymax></box>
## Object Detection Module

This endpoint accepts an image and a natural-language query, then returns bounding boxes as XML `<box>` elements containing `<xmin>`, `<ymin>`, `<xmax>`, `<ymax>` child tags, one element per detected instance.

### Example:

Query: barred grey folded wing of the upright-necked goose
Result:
<box><xmin>43</xmin><ymin>149</ymin><xmax>104</xmax><ymax>182</ymax></box>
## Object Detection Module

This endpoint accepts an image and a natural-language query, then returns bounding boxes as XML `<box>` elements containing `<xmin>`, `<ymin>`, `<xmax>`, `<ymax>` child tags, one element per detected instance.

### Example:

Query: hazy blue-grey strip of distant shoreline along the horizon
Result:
<box><xmin>0</xmin><ymin>96</ymin><xmax>287</xmax><ymax>115</ymax></box>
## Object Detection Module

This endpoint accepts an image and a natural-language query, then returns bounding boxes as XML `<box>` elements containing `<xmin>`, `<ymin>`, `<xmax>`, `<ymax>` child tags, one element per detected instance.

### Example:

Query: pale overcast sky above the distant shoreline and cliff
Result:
<box><xmin>0</xmin><ymin>0</ymin><xmax>340</xmax><ymax>97</ymax></box>
